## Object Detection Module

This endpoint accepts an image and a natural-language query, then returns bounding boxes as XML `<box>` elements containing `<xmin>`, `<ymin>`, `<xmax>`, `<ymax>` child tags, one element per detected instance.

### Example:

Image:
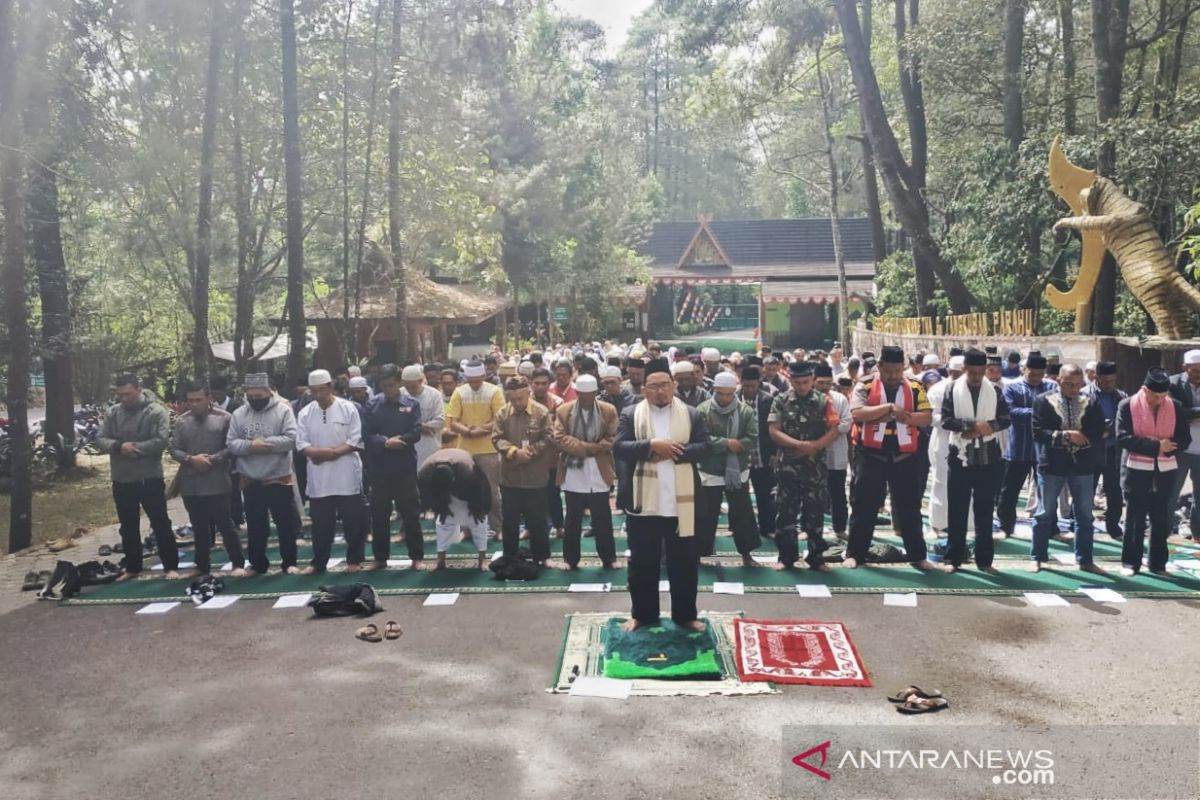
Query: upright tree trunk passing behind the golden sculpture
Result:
<box><xmin>1092</xmin><ymin>0</ymin><xmax>1129</xmax><ymax>336</ymax></box>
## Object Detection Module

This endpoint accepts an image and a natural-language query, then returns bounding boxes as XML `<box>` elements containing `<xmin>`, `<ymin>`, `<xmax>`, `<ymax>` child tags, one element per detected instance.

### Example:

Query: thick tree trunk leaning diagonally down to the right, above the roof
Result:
<box><xmin>836</xmin><ymin>0</ymin><xmax>974</xmax><ymax>314</ymax></box>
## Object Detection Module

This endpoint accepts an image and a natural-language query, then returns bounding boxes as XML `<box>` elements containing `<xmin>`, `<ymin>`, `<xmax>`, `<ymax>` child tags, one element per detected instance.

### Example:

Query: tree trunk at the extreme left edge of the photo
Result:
<box><xmin>0</xmin><ymin>0</ymin><xmax>34</xmax><ymax>553</ymax></box>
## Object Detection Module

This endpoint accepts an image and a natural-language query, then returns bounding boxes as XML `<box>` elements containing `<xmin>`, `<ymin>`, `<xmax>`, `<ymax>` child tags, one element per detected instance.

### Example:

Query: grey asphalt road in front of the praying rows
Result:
<box><xmin>0</xmin><ymin>594</ymin><xmax>1200</xmax><ymax>800</ymax></box>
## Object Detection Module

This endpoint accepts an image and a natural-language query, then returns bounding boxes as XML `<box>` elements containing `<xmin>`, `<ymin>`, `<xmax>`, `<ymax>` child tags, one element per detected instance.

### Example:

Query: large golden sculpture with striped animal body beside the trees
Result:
<box><xmin>1045</xmin><ymin>138</ymin><xmax>1200</xmax><ymax>339</ymax></box>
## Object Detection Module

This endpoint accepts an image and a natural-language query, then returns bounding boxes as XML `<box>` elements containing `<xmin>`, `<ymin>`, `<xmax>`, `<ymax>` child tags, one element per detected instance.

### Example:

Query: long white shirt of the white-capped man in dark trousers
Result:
<box><xmin>296</xmin><ymin>397</ymin><xmax>362</xmax><ymax>498</ymax></box>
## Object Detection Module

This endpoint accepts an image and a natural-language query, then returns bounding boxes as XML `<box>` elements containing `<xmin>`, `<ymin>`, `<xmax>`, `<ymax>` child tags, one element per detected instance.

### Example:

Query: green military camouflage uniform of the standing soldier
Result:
<box><xmin>767</xmin><ymin>389</ymin><xmax>829</xmax><ymax>566</ymax></box>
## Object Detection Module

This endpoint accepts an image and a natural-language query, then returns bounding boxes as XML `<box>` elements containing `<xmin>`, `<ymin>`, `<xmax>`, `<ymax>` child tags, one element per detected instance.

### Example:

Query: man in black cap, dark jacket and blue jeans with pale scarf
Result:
<box><xmin>1030</xmin><ymin>363</ymin><xmax>1106</xmax><ymax>575</ymax></box>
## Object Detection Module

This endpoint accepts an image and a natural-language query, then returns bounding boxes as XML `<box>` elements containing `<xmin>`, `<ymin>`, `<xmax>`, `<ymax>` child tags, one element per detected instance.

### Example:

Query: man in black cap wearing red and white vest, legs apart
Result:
<box><xmin>842</xmin><ymin>345</ymin><xmax>934</xmax><ymax>570</ymax></box>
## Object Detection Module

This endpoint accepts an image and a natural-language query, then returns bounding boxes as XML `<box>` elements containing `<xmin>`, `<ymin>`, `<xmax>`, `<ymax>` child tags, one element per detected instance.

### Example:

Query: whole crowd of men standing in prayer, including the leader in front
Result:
<box><xmin>100</xmin><ymin>339</ymin><xmax>1200</xmax><ymax>627</ymax></box>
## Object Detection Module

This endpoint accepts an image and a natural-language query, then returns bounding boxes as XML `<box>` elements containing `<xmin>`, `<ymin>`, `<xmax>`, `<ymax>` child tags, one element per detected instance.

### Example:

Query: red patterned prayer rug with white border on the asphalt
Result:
<box><xmin>733</xmin><ymin>618</ymin><xmax>871</xmax><ymax>686</ymax></box>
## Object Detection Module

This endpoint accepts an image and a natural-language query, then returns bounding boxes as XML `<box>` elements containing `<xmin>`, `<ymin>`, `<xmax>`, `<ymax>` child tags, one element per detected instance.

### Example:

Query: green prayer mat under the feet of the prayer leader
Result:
<box><xmin>604</xmin><ymin>618</ymin><xmax>721</xmax><ymax>680</ymax></box>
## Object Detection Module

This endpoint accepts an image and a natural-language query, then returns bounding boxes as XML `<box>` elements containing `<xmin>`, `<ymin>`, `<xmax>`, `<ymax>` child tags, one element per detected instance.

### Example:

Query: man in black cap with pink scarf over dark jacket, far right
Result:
<box><xmin>1117</xmin><ymin>368</ymin><xmax>1192</xmax><ymax>577</ymax></box>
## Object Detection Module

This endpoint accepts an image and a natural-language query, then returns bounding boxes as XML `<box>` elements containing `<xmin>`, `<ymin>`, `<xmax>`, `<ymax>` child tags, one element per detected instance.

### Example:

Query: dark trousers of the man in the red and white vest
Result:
<box><xmin>846</xmin><ymin>452</ymin><xmax>926</xmax><ymax>563</ymax></box>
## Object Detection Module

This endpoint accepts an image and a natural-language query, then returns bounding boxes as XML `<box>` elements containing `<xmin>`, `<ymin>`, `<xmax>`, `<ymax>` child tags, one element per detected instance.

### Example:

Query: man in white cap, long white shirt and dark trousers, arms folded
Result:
<box><xmin>296</xmin><ymin>369</ymin><xmax>364</xmax><ymax>575</ymax></box>
